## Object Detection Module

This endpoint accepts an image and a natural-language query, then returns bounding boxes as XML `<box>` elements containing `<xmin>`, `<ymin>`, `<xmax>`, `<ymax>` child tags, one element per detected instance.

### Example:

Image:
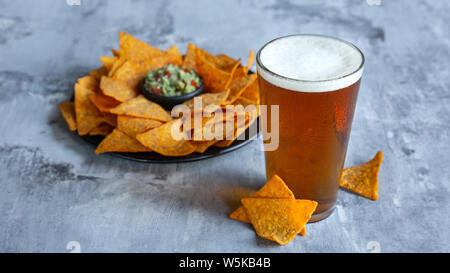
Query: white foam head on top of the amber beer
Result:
<box><xmin>257</xmin><ymin>35</ymin><xmax>364</xmax><ymax>92</ymax></box>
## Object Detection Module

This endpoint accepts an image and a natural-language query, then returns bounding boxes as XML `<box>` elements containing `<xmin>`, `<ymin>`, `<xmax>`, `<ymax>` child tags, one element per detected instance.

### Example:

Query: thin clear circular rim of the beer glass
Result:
<box><xmin>256</xmin><ymin>34</ymin><xmax>366</xmax><ymax>83</ymax></box>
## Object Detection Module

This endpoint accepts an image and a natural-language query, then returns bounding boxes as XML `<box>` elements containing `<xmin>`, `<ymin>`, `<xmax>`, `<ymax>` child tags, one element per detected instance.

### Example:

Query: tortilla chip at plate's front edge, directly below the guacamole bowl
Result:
<box><xmin>136</xmin><ymin>119</ymin><xmax>195</xmax><ymax>156</ymax></box>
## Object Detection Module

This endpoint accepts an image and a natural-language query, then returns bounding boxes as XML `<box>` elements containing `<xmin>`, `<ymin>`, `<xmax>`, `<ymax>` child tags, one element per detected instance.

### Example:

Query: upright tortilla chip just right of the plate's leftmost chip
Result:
<box><xmin>75</xmin><ymin>83</ymin><xmax>104</xmax><ymax>135</ymax></box>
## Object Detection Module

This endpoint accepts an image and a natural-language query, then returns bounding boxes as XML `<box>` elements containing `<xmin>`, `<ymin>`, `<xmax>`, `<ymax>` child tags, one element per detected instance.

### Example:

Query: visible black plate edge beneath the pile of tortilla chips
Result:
<box><xmin>81</xmin><ymin>118</ymin><xmax>260</xmax><ymax>163</ymax></box>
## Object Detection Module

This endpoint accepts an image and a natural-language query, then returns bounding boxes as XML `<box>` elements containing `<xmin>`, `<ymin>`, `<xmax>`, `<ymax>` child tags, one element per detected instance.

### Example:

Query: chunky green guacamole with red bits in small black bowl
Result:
<box><xmin>144</xmin><ymin>64</ymin><xmax>202</xmax><ymax>97</ymax></box>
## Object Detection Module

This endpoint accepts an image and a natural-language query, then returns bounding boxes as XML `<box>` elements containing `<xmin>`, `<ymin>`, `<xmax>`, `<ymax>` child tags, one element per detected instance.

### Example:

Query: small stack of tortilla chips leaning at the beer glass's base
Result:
<box><xmin>230</xmin><ymin>175</ymin><xmax>317</xmax><ymax>245</ymax></box>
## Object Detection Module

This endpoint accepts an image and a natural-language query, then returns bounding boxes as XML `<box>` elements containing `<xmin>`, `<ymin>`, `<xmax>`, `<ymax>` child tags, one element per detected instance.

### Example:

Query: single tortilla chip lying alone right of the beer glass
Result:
<box><xmin>339</xmin><ymin>151</ymin><xmax>383</xmax><ymax>200</ymax></box>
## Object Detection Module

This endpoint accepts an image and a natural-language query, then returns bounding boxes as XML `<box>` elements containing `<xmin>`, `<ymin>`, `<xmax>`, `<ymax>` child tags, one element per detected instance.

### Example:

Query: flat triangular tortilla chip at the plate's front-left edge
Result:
<box><xmin>95</xmin><ymin>129</ymin><xmax>151</xmax><ymax>154</ymax></box>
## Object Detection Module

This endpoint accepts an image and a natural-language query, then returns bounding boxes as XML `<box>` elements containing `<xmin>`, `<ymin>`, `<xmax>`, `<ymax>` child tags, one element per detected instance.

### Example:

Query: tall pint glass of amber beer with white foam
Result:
<box><xmin>256</xmin><ymin>35</ymin><xmax>364</xmax><ymax>222</ymax></box>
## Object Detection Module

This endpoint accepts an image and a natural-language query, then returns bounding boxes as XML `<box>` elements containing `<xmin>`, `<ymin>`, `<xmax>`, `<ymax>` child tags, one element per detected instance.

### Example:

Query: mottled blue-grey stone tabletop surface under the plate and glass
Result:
<box><xmin>0</xmin><ymin>0</ymin><xmax>450</xmax><ymax>252</ymax></box>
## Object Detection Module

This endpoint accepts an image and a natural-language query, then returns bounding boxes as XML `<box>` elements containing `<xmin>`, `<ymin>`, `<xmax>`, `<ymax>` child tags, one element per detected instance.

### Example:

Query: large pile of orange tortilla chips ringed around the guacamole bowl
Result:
<box><xmin>60</xmin><ymin>32</ymin><xmax>259</xmax><ymax>156</ymax></box>
